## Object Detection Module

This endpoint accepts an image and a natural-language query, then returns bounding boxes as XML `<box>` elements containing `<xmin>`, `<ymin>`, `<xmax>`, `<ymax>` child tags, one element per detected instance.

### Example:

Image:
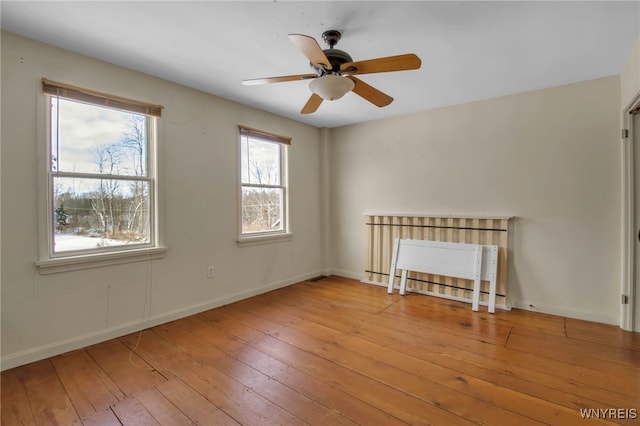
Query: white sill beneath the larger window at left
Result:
<box><xmin>36</xmin><ymin>247</ymin><xmax>168</xmax><ymax>275</ymax></box>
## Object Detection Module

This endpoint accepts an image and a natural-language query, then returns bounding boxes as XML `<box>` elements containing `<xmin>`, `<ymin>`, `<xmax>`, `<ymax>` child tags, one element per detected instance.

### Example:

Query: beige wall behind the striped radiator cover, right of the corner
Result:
<box><xmin>329</xmin><ymin>77</ymin><xmax>621</xmax><ymax>324</ymax></box>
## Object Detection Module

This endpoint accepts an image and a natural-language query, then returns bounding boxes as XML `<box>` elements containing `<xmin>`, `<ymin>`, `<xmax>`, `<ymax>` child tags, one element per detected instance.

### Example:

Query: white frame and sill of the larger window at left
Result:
<box><xmin>35</xmin><ymin>79</ymin><xmax>167</xmax><ymax>274</ymax></box>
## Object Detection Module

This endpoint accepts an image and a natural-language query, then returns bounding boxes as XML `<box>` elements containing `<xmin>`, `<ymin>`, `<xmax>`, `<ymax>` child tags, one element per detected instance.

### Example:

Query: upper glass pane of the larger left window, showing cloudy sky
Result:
<box><xmin>51</xmin><ymin>97</ymin><xmax>147</xmax><ymax>176</ymax></box>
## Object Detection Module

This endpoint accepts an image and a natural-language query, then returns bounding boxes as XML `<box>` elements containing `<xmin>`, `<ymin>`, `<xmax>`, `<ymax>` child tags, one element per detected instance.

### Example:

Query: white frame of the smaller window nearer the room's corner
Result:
<box><xmin>237</xmin><ymin>125</ymin><xmax>293</xmax><ymax>247</ymax></box>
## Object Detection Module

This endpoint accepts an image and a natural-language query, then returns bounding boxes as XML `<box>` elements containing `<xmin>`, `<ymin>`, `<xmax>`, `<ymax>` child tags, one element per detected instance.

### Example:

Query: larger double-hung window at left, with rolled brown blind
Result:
<box><xmin>41</xmin><ymin>80</ymin><xmax>161</xmax><ymax>268</ymax></box>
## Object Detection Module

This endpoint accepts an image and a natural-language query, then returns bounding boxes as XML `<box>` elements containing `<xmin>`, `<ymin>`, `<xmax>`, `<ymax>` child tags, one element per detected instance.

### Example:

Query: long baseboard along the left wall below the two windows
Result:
<box><xmin>0</xmin><ymin>271</ymin><xmax>325</xmax><ymax>371</ymax></box>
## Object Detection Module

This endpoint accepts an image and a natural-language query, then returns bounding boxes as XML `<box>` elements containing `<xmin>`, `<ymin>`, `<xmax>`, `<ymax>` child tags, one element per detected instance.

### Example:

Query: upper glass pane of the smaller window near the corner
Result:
<box><xmin>240</xmin><ymin>138</ymin><xmax>280</xmax><ymax>185</ymax></box>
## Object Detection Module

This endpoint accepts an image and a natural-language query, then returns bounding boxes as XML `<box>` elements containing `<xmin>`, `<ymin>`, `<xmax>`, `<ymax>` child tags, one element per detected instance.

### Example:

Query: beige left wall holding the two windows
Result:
<box><xmin>1</xmin><ymin>33</ymin><xmax>325</xmax><ymax>368</ymax></box>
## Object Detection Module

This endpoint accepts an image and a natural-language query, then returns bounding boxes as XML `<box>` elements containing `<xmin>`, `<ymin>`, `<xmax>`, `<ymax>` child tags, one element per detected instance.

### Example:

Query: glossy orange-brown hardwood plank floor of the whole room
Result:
<box><xmin>1</xmin><ymin>277</ymin><xmax>640</xmax><ymax>426</ymax></box>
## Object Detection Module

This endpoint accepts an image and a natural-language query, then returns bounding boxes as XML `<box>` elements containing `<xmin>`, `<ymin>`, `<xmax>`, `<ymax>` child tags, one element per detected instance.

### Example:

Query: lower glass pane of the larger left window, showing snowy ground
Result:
<box><xmin>53</xmin><ymin>177</ymin><xmax>150</xmax><ymax>253</ymax></box>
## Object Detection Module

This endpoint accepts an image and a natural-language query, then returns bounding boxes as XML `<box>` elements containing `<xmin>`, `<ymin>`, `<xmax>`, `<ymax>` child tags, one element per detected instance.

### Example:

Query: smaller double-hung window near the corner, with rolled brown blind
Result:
<box><xmin>240</xmin><ymin>127</ymin><xmax>291</xmax><ymax>237</ymax></box>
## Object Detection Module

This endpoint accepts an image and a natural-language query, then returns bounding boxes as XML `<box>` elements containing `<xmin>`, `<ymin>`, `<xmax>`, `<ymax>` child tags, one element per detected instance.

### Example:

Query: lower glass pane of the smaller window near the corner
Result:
<box><xmin>242</xmin><ymin>187</ymin><xmax>284</xmax><ymax>234</ymax></box>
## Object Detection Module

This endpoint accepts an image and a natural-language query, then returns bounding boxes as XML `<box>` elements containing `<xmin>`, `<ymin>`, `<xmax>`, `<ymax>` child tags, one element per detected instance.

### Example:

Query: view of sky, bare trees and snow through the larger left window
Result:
<box><xmin>52</xmin><ymin>101</ymin><xmax>151</xmax><ymax>252</ymax></box>
